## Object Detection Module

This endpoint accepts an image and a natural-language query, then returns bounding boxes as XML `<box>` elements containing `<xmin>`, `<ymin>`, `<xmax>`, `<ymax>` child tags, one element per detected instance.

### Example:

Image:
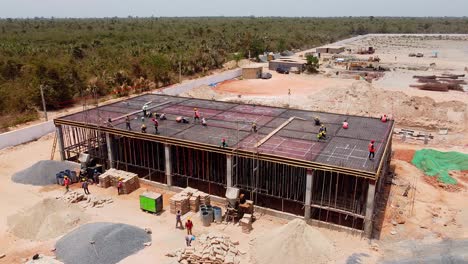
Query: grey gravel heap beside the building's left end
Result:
<box><xmin>11</xmin><ymin>160</ymin><xmax>80</xmax><ymax>186</ymax></box>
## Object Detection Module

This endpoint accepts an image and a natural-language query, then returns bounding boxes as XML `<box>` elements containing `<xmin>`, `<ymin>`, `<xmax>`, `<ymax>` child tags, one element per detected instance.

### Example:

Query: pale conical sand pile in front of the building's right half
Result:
<box><xmin>252</xmin><ymin>219</ymin><xmax>334</xmax><ymax>264</ymax></box>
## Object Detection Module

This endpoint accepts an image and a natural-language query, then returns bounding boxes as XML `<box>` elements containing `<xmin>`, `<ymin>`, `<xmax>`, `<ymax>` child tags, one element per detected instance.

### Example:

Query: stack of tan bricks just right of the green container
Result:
<box><xmin>169</xmin><ymin>187</ymin><xmax>210</xmax><ymax>214</ymax></box>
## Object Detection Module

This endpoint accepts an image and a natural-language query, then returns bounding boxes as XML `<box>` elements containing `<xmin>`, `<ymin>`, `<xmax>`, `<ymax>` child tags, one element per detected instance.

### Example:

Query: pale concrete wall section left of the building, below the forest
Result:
<box><xmin>0</xmin><ymin>121</ymin><xmax>55</xmax><ymax>149</ymax></box>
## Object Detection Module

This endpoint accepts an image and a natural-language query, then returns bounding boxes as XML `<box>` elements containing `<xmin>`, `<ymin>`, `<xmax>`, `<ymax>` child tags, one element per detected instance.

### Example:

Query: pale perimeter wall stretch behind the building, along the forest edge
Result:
<box><xmin>160</xmin><ymin>69</ymin><xmax>242</xmax><ymax>95</ymax></box>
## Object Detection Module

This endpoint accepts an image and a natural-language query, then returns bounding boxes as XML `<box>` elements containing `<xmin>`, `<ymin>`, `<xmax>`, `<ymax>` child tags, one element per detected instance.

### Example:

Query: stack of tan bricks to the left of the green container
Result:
<box><xmin>99</xmin><ymin>169</ymin><xmax>140</xmax><ymax>194</ymax></box>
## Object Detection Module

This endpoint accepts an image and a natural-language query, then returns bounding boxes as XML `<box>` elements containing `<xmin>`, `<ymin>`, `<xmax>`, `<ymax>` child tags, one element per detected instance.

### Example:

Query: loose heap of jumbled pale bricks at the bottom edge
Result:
<box><xmin>166</xmin><ymin>233</ymin><xmax>244</xmax><ymax>264</ymax></box>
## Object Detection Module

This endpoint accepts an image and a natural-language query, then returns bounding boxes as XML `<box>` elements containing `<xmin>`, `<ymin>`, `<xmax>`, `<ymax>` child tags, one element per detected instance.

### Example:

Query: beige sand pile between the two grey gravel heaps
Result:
<box><xmin>8</xmin><ymin>198</ymin><xmax>88</xmax><ymax>240</ymax></box>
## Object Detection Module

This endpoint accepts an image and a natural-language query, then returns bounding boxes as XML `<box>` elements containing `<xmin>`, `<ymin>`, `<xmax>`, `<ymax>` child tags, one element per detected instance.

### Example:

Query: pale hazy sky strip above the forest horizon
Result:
<box><xmin>0</xmin><ymin>0</ymin><xmax>468</xmax><ymax>18</ymax></box>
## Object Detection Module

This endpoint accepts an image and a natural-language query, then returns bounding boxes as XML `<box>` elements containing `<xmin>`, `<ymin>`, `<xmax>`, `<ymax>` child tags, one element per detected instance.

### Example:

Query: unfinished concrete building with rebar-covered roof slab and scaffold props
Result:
<box><xmin>54</xmin><ymin>94</ymin><xmax>393</xmax><ymax>236</ymax></box>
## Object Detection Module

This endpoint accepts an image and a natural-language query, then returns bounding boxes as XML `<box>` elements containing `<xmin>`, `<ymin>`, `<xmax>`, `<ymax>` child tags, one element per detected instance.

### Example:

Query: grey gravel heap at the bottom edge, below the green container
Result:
<box><xmin>55</xmin><ymin>223</ymin><xmax>151</xmax><ymax>264</ymax></box>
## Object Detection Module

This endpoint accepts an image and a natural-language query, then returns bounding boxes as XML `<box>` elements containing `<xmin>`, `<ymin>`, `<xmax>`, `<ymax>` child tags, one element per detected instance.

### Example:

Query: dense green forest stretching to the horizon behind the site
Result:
<box><xmin>0</xmin><ymin>17</ymin><xmax>468</xmax><ymax>129</ymax></box>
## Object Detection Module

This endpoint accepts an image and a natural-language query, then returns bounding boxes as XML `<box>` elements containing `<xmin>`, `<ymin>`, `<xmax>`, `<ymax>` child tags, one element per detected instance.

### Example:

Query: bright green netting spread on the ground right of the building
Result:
<box><xmin>411</xmin><ymin>149</ymin><xmax>468</xmax><ymax>184</ymax></box>
